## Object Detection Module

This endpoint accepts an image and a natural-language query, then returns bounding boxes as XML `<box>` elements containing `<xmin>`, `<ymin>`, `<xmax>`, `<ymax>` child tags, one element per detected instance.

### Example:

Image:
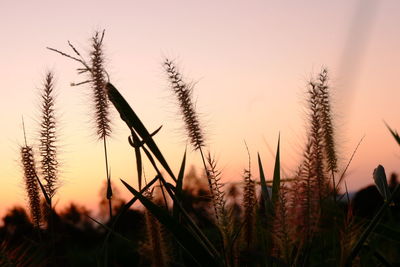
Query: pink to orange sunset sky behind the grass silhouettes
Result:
<box><xmin>0</xmin><ymin>0</ymin><xmax>400</xmax><ymax>218</ymax></box>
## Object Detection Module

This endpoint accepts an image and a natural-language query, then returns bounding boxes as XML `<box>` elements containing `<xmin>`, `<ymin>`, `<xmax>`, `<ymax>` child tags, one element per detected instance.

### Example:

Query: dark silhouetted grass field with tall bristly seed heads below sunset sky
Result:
<box><xmin>0</xmin><ymin>31</ymin><xmax>400</xmax><ymax>266</ymax></box>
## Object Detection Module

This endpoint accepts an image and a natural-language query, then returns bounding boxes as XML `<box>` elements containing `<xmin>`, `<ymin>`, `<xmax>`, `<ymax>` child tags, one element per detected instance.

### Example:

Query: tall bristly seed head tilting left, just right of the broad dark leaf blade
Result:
<box><xmin>163</xmin><ymin>59</ymin><xmax>204</xmax><ymax>150</ymax></box>
